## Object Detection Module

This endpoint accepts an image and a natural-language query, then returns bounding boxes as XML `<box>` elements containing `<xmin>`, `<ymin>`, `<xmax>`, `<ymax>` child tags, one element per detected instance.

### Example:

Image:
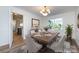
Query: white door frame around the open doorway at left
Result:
<box><xmin>9</xmin><ymin>11</ymin><xmax>24</xmax><ymax>48</ymax></box>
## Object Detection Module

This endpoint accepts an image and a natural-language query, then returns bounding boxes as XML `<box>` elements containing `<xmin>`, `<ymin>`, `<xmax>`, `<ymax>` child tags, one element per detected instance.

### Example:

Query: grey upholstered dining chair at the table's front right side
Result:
<box><xmin>50</xmin><ymin>35</ymin><xmax>65</xmax><ymax>52</ymax></box>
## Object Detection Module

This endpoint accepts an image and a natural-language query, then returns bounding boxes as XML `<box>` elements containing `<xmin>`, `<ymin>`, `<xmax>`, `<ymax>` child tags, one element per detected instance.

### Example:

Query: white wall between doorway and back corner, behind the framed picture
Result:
<box><xmin>10</xmin><ymin>7</ymin><xmax>40</xmax><ymax>47</ymax></box>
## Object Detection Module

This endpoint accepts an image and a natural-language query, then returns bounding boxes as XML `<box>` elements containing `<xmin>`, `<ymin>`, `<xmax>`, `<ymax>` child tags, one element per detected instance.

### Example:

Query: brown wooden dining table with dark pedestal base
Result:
<box><xmin>31</xmin><ymin>32</ymin><xmax>59</xmax><ymax>52</ymax></box>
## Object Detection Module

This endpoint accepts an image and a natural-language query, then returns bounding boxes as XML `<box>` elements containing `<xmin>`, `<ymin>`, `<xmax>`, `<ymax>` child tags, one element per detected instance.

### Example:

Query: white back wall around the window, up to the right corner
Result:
<box><xmin>41</xmin><ymin>11</ymin><xmax>76</xmax><ymax>38</ymax></box>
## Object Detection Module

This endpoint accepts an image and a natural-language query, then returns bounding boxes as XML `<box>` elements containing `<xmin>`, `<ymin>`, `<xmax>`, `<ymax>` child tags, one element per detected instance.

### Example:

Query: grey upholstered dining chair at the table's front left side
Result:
<box><xmin>26</xmin><ymin>34</ymin><xmax>42</xmax><ymax>53</ymax></box>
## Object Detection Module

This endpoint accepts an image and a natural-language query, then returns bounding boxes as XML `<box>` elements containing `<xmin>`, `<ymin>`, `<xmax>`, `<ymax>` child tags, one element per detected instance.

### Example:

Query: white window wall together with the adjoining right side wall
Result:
<box><xmin>41</xmin><ymin>8</ymin><xmax>79</xmax><ymax>45</ymax></box>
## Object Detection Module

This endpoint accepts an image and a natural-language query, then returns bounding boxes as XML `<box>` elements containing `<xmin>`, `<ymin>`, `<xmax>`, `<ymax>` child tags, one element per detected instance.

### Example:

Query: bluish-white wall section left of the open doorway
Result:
<box><xmin>0</xmin><ymin>7</ymin><xmax>9</xmax><ymax>46</ymax></box>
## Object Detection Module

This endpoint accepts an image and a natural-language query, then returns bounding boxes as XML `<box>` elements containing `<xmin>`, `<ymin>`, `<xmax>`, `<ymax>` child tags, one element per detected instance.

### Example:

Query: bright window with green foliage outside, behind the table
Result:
<box><xmin>48</xmin><ymin>18</ymin><xmax>63</xmax><ymax>30</ymax></box>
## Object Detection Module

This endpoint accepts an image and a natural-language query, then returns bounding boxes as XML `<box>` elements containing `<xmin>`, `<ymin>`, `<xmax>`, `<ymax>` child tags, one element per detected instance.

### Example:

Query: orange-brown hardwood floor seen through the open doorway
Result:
<box><xmin>12</xmin><ymin>32</ymin><xmax>24</xmax><ymax>47</ymax></box>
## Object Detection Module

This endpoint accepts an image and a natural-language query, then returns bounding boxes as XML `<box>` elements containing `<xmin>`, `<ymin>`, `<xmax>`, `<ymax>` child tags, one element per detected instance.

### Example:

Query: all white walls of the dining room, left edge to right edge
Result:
<box><xmin>0</xmin><ymin>7</ymin><xmax>79</xmax><ymax>46</ymax></box>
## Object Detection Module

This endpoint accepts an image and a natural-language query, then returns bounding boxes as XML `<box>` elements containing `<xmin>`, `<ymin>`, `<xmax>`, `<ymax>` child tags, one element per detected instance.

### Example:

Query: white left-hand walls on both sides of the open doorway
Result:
<box><xmin>0</xmin><ymin>7</ymin><xmax>40</xmax><ymax>47</ymax></box>
